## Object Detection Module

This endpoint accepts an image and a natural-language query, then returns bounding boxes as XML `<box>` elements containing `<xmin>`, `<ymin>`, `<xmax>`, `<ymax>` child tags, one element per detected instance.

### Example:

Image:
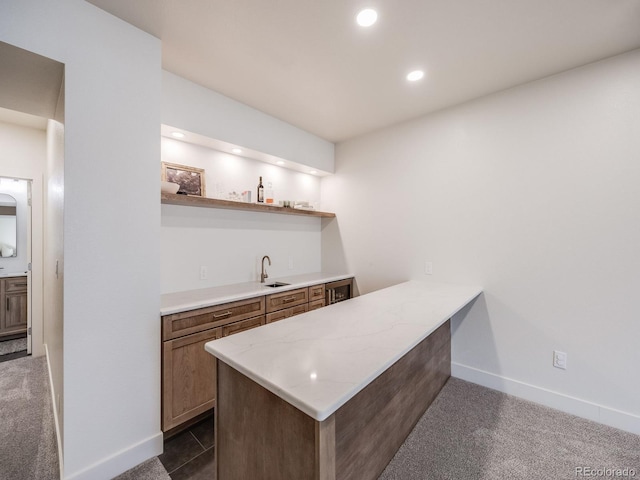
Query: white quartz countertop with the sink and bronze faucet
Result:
<box><xmin>160</xmin><ymin>272</ymin><xmax>353</xmax><ymax>315</ymax></box>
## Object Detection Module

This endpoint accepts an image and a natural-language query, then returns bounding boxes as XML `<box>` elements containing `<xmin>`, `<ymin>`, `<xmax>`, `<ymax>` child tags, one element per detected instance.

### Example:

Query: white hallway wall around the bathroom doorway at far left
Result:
<box><xmin>0</xmin><ymin>123</ymin><xmax>46</xmax><ymax>356</ymax></box>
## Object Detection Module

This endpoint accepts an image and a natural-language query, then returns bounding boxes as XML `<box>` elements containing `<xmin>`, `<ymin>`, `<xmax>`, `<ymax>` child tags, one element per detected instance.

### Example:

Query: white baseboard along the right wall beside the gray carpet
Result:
<box><xmin>451</xmin><ymin>362</ymin><xmax>640</xmax><ymax>435</ymax></box>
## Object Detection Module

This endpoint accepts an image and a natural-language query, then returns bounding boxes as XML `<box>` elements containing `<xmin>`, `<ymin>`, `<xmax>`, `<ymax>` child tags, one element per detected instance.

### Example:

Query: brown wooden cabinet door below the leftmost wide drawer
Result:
<box><xmin>162</xmin><ymin>328</ymin><xmax>222</xmax><ymax>432</ymax></box>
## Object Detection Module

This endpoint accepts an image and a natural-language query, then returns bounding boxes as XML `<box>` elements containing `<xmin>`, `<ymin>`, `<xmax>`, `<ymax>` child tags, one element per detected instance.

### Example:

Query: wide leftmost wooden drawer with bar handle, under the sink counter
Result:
<box><xmin>162</xmin><ymin>297</ymin><xmax>265</xmax><ymax>340</ymax></box>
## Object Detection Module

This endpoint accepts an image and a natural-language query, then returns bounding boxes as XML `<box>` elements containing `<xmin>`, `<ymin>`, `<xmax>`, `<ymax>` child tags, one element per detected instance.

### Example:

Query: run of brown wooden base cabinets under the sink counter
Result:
<box><xmin>162</xmin><ymin>279</ymin><xmax>353</xmax><ymax>435</ymax></box>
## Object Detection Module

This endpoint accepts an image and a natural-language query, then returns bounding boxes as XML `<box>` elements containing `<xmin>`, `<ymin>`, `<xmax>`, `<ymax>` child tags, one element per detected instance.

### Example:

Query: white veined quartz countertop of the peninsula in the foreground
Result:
<box><xmin>205</xmin><ymin>281</ymin><xmax>482</xmax><ymax>421</ymax></box>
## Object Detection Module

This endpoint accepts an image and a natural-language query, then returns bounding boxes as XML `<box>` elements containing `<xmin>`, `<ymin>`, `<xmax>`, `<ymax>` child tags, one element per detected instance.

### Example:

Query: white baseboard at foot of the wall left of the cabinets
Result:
<box><xmin>61</xmin><ymin>432</ymin><xmax>163</xmax><ymax>480</ymax></box>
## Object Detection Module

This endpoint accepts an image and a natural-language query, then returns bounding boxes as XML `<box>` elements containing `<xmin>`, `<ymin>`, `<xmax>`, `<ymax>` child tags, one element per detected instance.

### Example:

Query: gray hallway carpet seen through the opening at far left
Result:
<box><xmin>0</xmin><ymin>357</ymin><xmax>60</xmax><ymax>480</ymax></box>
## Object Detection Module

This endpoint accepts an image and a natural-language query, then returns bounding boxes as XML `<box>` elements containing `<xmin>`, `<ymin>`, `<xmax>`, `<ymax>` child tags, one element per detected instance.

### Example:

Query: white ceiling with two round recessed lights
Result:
<box><xmin>88</xmin><ymin>0</ymin><xmax>640</xmax><ymax>142</ymax></box>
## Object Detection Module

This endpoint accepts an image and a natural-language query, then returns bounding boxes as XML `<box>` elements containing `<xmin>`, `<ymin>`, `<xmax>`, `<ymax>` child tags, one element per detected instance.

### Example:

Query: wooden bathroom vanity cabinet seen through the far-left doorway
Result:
<box><xmin>0</xmin><ymin>276</ymin><xmax>27</xmax><ymax>338</ymax></box>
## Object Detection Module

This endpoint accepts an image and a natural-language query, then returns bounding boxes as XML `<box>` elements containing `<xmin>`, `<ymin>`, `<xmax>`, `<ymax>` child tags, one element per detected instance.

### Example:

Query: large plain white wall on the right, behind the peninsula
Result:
<box><xmin>321</xmin><ymin>50</ymin><xmax>640</xmax><ymax>433</ymax></box>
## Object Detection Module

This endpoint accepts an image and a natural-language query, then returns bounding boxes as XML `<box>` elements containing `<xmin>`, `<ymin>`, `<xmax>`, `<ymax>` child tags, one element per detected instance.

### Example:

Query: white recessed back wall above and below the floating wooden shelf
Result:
<box><xmin>161</xmin><ymin>138</ymin><xmax>321</xmax><ymax>293</ymax></box>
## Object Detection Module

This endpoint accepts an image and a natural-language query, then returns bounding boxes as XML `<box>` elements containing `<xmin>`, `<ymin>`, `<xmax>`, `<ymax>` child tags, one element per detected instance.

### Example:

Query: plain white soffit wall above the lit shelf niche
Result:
<box><xmin>162</xmin><ymin>71</ymin><xmax>334</xmax><ymax>172</ymax></box>
